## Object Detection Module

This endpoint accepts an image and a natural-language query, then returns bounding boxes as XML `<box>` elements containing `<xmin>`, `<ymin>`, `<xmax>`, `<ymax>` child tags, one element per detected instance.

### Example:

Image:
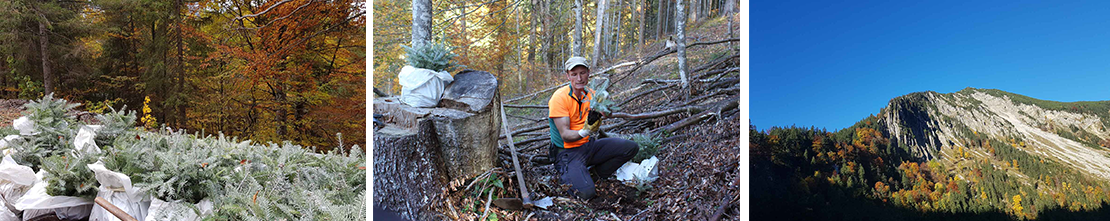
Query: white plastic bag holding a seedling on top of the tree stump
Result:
<box><xmin>397</xmin><ymin>66</ymin><xmax>455</xmax><ymax>108</ymax></box>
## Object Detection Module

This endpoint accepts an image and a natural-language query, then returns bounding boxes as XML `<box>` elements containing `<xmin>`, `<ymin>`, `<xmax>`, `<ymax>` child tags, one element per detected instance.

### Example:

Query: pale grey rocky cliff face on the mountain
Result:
<box><xmin>878</xmin><ymin>88</ymin><xmax>1110</xmax><ymax>180</ymax></box>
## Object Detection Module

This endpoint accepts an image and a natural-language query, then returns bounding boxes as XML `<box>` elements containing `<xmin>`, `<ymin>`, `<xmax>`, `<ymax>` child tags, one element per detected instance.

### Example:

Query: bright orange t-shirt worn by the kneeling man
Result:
<box><xmin>547</xmin><ymin>86</ymin><xmax>594</xmax><ymax>149</ymax></box>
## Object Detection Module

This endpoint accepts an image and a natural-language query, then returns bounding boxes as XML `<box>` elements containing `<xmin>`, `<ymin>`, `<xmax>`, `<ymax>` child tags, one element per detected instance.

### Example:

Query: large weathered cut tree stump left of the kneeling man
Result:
<box><xmin>374</xmin><ymin>70</ymin><xmax>501</xmax><ymax>220</ymax></box>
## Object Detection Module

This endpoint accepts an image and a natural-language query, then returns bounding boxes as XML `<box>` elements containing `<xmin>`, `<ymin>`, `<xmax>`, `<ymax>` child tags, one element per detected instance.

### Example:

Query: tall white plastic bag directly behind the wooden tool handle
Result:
<box><xmin>88</xmin><ymin>161</ymin><xmax>151</xmax><ymax>221</ymax></box>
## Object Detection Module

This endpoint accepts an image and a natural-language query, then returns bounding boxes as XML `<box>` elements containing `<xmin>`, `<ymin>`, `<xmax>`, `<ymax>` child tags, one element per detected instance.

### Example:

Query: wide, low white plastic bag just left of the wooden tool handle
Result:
<box><xmin>16</xmin><ymin>171</ymin><xmax>92</xmax><ymax>220</ymax></box>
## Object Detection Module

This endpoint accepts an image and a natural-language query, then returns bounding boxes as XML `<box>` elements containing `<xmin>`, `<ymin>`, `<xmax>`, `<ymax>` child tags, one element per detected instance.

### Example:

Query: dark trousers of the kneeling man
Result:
<box><xmin>555</xmin><ymin>138</ymin><xmax>639</xmax><ymax>199</ymax></box>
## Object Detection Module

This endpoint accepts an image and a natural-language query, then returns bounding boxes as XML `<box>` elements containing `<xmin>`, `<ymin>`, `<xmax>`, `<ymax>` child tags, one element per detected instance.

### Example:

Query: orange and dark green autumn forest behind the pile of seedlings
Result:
<box><xmin>0</xmin><ymin>0</ymin><xmax>366</xmax><ymax>151</ymax></box>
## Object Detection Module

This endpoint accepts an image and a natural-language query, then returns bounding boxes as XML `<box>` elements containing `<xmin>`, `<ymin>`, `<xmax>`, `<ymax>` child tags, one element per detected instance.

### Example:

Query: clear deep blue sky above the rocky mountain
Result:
<box><xmin>749</xmin><ymin>0</ymin><xmax>1110</xmax><ymax>131</ymax></box>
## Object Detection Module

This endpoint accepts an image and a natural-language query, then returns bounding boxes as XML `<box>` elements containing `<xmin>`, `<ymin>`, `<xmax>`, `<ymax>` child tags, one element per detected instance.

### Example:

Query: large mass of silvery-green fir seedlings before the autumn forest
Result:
<box><xmin>4</xmin><ymin>96</ymin><xmax>365</xmax><ymax>220</ymax></box>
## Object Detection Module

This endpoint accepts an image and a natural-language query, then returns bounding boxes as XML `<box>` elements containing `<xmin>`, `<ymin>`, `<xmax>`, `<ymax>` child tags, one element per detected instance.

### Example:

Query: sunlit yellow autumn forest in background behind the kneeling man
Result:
<box><xmin>373</xmin><ymin>0</ymin><xmax>736</xmax><ymax>96</ymax></box>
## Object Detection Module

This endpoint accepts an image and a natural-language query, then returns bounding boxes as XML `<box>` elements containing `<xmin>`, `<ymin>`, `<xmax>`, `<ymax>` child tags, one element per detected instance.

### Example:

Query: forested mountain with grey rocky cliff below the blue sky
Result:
<box><xmin>749</xmin><ymin>88</ymin><xmax>1110</xmax><ymax>220</ymax></box>
